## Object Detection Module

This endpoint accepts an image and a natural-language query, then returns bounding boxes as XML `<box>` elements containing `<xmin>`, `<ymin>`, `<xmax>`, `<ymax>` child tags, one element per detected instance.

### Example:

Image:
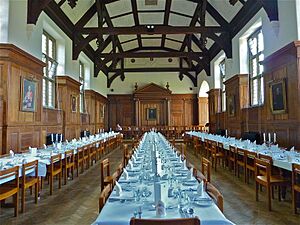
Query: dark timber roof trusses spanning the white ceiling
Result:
<box><xmin>27</xmin><ymin>0</ymin><xmax>278</xmax><ymax>87</ymax></box>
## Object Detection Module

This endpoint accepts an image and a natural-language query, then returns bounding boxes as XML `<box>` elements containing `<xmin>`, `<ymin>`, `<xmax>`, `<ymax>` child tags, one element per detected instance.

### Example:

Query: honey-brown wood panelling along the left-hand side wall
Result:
<box><xmin>0</xmin><ymin>44</ymin><xmax>106</xmax><ymax>154</ymax></box>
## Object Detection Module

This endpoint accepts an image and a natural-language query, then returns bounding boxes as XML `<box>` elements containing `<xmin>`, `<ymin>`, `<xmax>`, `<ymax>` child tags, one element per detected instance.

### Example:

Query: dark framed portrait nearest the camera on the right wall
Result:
<box><xmin>270</xmin><ymin>79</ymin><xmax>287</xmax><ymax>114</ymax></box>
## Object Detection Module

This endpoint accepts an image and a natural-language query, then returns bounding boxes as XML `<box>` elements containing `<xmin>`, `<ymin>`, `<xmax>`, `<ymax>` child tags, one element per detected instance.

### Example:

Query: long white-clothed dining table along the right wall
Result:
<box><xmin>186</xmin><ymin>131</ymin><xmax>300</xmax><ymax>171</ymax></box>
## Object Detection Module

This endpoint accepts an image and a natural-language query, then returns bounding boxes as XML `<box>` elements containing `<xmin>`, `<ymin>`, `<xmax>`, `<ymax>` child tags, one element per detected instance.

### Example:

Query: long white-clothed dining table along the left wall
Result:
<box><xmin>0</xmin><ymin>131</ymin><xmax>119</xmax><ymax>184</ymax></box>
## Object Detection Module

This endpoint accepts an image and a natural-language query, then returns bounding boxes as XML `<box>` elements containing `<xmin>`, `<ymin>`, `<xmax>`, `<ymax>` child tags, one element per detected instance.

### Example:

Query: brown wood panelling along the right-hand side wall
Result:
<box><xmin>209</xmin><ymin>41</ymin><xmax>300</xmax><ymax>149</ymax></box>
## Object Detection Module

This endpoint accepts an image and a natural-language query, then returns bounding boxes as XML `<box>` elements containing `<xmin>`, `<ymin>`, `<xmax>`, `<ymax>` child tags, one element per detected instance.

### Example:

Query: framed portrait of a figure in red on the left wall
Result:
<box><xmin>20</xmin><ymin>77</ymin><xmax>37</xmax><ymax>112</ymax></box>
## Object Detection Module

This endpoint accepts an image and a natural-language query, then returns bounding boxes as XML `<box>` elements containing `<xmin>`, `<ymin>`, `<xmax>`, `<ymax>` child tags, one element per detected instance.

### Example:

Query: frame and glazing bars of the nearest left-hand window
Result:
<box><xmin>42</xmin><ymin>30</ymin><xmax>58</xmax><ymax>108</ymax></box>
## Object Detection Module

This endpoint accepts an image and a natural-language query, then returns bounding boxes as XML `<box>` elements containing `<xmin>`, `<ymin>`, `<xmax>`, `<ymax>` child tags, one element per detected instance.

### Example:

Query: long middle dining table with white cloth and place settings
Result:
<box><xmin>93</xmin><ymin>131</ymin><xmax>233</xmax><ymax>225</ymax></box>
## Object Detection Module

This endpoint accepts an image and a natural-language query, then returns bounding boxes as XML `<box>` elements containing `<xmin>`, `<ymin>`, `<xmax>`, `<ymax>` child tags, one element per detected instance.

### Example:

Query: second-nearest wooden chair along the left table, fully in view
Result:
<box><xmin>20</xmin><ymin>160</ymin><xmax>39</xmax><ymax>213</ymax></box>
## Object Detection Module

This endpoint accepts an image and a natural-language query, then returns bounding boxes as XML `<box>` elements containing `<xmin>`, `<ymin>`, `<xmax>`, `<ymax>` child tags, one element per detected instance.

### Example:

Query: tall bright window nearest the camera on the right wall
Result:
<box><xmin>248</xmin><ymin>28</ymin><xmax>264</xmax><ymax>106</ymax></box>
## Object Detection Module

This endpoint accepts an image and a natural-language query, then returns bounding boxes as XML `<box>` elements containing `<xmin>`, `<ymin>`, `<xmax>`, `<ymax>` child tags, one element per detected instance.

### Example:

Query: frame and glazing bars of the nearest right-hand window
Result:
<box><xmin>247</xmin><ymin>27</ymin><xmax>265</xmax><ymax>107</ymax></box>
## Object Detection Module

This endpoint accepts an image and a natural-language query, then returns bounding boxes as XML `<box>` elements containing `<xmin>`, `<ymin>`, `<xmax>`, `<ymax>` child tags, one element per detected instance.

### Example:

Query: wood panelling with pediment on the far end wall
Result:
<box><xmin>108</xmin><ymin>84</ymin><xmax>198</xmax><ymax>128</ymax></box>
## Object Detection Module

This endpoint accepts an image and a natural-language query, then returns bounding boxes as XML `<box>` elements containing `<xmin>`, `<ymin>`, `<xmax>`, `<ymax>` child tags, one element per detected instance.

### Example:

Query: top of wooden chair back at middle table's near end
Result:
<box><xmin>130</xmin><ymin>217</ymin><xmax>200</xmax><ymax>225</ymax></box>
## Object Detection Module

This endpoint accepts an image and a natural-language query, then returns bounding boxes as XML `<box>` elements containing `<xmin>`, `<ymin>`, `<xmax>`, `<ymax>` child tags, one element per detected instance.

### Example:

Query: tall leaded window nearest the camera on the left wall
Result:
<box><xmin>42</xmin><ymin>32</ymin><xmax>57</xmax><ymax>108</ymax></box>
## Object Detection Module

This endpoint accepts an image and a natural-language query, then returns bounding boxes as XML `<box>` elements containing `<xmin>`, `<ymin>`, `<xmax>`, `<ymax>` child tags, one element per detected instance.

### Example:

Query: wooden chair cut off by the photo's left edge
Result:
<box><xmin>0</xmin><ymin>166</ymin><xmax>19</xmax><ymax>217</ymax></box>
